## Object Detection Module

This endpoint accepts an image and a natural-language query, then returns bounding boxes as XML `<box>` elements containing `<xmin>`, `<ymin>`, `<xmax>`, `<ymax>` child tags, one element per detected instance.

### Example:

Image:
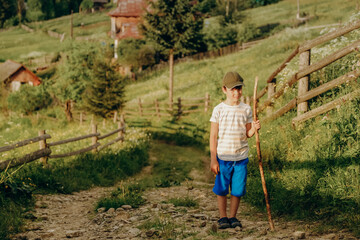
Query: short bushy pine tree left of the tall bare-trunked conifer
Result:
<box><xmin>84</xmin><ymin>59</ymin><xmax>125</xmax><ymax>118</ymax></box>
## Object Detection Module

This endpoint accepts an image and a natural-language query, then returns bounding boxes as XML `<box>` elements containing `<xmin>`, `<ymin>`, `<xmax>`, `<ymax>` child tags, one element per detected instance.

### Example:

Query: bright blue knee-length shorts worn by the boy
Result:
<box><xmin>213</xmin><ymin>158</ymin><xmax>249</xmax><ymax>197</ymax></box>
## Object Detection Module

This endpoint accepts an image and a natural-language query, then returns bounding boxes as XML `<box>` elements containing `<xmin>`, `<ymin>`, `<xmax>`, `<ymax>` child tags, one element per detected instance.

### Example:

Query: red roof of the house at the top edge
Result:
<box><xmin>108</xmin><ymin>0</ymin><xmax>147</xmax><ymax>17</ymax></box>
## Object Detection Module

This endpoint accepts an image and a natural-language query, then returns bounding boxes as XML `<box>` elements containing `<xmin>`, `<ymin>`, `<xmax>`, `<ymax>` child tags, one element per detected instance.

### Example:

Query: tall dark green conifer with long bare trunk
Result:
<box><xmin>140</xmin><ymin>0</ymin><xmax>205</xmax><ymax>106</ymax></box>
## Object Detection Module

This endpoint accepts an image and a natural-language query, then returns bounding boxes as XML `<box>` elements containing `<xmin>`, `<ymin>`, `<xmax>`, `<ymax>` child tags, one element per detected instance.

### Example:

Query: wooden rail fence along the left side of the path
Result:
<box><xmin>0</xmin><ymin>118</ymin><xmax>125</xmax><ymax>172</ymax></box>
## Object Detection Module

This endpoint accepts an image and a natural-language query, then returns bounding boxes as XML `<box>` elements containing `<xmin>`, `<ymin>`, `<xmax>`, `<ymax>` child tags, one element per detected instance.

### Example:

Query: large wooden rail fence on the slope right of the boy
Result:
<box><xmin>257</xmin><ymin>21</ymin><xmax>360</xmax><ymax>126</ymax></box>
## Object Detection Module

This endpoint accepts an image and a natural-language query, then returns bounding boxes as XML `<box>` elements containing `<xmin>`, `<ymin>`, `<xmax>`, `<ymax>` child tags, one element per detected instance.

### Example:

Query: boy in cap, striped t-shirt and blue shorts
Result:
<box><xmin>210</xmin><ymin>72</ymin><xmax>261</xmax><ymax>229</ymax></box>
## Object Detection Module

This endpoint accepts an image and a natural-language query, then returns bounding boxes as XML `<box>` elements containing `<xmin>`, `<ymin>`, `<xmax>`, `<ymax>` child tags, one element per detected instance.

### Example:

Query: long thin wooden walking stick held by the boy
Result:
<box><xmin>253</xmin><ymin>77</ymin><xmax>275</xmax><ymax>231</ymax></box>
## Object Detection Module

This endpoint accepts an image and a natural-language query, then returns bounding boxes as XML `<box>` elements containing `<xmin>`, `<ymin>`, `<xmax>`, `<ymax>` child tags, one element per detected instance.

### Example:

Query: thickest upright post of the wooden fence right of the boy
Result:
<box><xmin>297</xmin><ymin>50</ymin><xmax>311</xmax><ymax>116</ymax></box>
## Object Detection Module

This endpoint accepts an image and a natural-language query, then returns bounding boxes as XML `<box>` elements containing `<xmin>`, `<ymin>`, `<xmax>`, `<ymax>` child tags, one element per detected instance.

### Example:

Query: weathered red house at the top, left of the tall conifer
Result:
<box><xmin>108</xmin><ymin>0</ymin><xmax>147</xmax><ymax>58</ymax></box>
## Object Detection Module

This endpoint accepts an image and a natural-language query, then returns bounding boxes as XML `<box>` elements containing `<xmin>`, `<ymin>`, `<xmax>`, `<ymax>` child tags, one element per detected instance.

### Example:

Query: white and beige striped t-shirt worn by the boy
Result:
<box><xmin>210</xmin><ymin>102</ymin><xmax>253</xmax><ymax>161</ymax></box>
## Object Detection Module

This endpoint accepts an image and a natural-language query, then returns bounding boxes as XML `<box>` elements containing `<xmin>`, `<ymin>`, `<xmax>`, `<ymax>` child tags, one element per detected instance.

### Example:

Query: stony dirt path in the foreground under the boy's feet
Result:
<box><xmin>13</xmin><ymin>143</ymin><xmax>356</xmax><ymax>240</ymax></box>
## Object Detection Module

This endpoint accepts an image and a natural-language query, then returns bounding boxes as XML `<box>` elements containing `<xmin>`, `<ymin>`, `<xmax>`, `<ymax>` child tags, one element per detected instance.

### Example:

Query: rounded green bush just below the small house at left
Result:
<box><xmin>7</xmin><ymin>84</ymin><xmax>52</xmax><ymax>114</ymax></box>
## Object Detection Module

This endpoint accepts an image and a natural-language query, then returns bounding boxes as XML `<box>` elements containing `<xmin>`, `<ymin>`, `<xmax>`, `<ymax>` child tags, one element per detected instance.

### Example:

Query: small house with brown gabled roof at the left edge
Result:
<box><xmin>0</xmin><ymin>60</ymin><xmax>41</xmax><ymax>91</ymax></box>
